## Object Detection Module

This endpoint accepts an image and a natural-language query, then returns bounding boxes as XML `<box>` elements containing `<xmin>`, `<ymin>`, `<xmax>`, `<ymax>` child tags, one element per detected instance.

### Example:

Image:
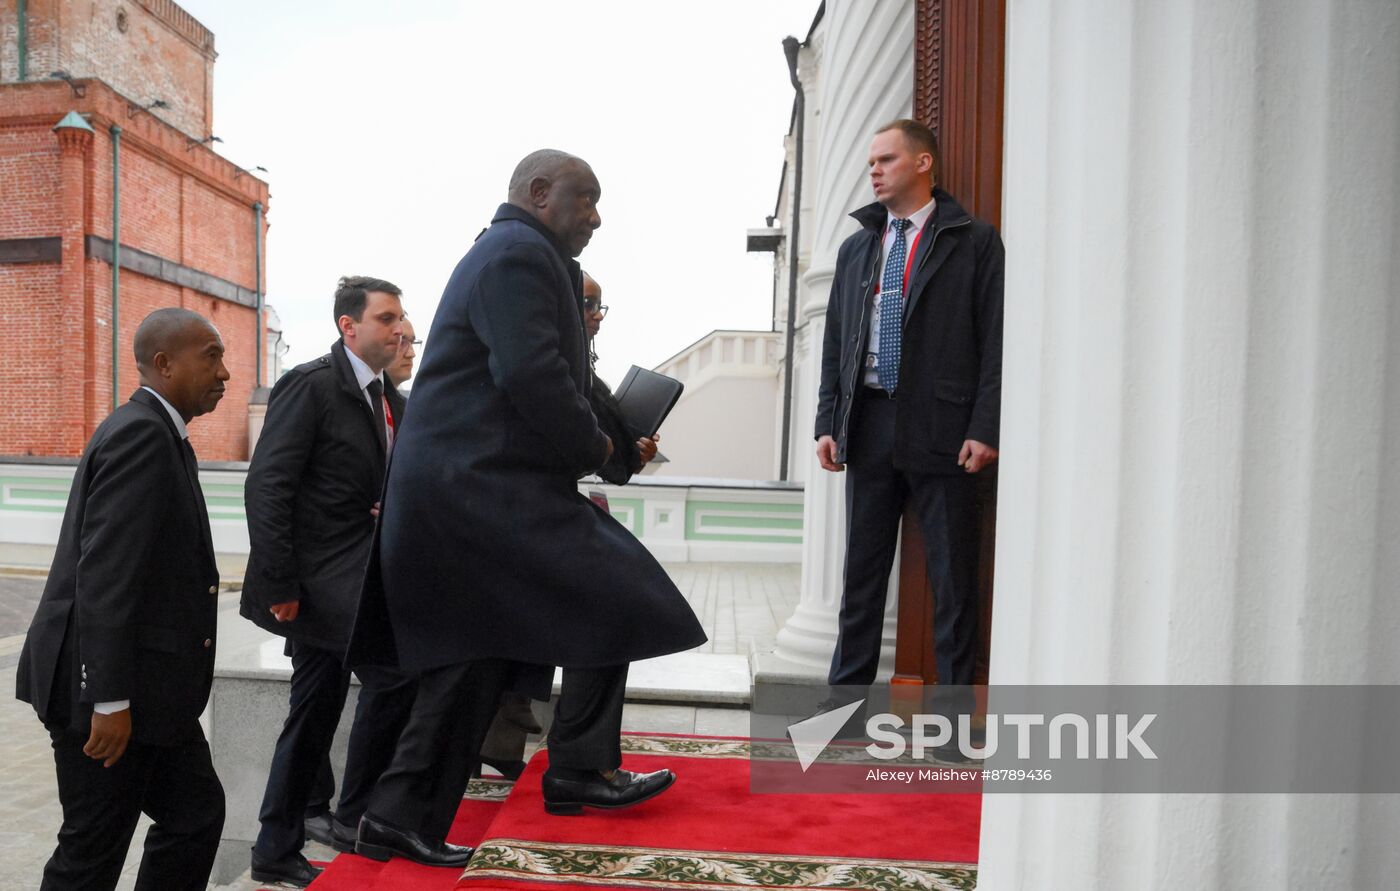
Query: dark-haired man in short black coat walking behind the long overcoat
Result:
<box><xmin>241</xmin><ymin>276</ymin><xmax>413</xmax><ymax>887</ymax></box>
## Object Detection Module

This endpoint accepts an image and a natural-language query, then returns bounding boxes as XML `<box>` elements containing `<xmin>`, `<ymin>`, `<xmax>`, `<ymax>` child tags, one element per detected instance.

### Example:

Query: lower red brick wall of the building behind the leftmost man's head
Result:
<box><xmin>0</xmin><ymin>81</ymin><xmax>267</xmax><ymax>461</ymax></box>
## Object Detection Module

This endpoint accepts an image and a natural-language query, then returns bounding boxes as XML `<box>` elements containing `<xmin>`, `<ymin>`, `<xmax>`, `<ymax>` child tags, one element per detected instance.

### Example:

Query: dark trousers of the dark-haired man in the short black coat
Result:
<box><xmin>253</xmin><ymin>642</ymin><xmax>414</xmax><ymax>860</ymax></box>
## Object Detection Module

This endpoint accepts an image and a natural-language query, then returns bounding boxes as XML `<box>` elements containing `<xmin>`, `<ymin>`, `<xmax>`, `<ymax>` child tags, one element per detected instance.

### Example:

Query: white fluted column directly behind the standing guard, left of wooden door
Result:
<box><xmin>774</xmin><ymin>0</ymin><xmax>914</xmax><ymax>677</ymax></box>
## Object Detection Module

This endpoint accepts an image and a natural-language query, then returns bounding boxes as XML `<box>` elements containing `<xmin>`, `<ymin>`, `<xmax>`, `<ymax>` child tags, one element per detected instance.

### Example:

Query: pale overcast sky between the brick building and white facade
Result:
<box><xmin>179</xmin><ymin>0</ymin><xmax>818</xmax><ymax>384</ymax></box>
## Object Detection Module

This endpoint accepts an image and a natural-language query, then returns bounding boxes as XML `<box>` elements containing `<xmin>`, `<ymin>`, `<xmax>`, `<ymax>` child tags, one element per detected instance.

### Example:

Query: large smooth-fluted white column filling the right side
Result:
<box><xmin>979</xmin><ymin>0</ymin><xmax>1400</xmax><ymax>891</ymax></box>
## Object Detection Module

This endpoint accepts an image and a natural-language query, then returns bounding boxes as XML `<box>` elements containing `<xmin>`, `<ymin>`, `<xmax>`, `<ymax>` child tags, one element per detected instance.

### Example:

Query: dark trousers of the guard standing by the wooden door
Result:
<box><xmin>827</xmin><ymin>389</ymin><xmax>977</xmax><ymax>686</ymax></box>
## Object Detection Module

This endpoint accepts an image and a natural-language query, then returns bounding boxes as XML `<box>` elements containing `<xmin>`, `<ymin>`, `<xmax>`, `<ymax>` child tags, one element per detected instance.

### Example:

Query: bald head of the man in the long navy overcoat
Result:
<box><xmin>508</xmin><ymin>149</ymin><xmax>603</xmax><ymax>256</ymax></box>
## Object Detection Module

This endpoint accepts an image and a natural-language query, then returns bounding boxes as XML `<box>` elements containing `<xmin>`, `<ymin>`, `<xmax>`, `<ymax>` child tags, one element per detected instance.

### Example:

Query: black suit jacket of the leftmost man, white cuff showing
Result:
<box><xmin>15</xmin><ymin>389</ymin><xmax>218</xmax><ymax>744</ymax></box>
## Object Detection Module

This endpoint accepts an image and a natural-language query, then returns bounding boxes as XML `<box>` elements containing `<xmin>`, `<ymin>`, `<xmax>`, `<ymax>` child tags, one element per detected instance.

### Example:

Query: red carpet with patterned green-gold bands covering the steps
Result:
<box><xmin>298</xmin><ymin>734</ymin><xmax>981</xmax><ymax>891</ymax></box>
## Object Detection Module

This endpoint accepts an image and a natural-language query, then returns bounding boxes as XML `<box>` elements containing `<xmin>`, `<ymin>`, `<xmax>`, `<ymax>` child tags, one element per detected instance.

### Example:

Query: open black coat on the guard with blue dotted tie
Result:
<box><xmin>815</xmin><ymin>189</ymin><xmax>1005</xmax><ymax>474</ymax></box>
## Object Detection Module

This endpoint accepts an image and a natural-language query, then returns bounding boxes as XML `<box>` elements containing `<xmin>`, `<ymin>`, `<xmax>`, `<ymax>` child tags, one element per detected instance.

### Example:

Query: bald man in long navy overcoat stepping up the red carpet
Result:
<box><xmin>350</xmin><ymin>150</ymin><xmax>704</xmax><ymax>866</ymax></box>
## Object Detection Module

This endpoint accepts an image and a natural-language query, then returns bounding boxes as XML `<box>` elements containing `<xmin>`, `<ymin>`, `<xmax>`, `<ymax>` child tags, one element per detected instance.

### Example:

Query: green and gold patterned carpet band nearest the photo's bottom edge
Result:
<box><xmin>458</xmin><ymin>839</ymin><xmax>977</xmax><ymax>891</ymax></box>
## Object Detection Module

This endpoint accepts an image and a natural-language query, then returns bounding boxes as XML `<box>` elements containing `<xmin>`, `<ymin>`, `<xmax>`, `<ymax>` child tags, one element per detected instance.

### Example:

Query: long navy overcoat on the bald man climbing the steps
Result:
<box><xmin>351</xmin><ymin>205</ymin><xmax>706</xmax><ymax>670</ymax></box>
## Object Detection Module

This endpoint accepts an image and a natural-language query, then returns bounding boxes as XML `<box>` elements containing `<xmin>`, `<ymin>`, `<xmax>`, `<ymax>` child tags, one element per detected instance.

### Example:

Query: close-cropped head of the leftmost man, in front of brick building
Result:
<box><xmin>132</xmin><ymin>308</ymin><xmax>228</xmax><ymax>422</ymax></box>
